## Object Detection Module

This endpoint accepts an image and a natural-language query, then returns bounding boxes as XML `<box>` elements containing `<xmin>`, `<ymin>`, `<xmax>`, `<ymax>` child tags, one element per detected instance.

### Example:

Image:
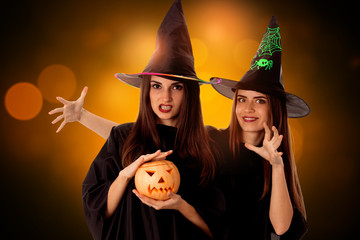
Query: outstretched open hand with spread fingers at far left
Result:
<box><xmin>49</xmin><ymin>87</ymin><xmax>88</xmax><ymax>133</ymax></box>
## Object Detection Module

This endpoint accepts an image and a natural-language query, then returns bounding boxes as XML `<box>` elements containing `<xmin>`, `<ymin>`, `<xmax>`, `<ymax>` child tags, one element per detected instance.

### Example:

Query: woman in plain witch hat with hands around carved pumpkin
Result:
<box><xmin>48</xmin><ymin>0</ymin><xmax>222</xmax><ymax>240</ymax></box>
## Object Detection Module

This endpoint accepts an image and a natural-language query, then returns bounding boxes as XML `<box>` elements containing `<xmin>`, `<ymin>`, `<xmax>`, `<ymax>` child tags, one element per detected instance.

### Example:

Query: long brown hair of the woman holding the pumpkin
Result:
<box><xmin>122</xmin><ymin>76</ymin><xmax>215</xmax><ymax>184</ymax></box>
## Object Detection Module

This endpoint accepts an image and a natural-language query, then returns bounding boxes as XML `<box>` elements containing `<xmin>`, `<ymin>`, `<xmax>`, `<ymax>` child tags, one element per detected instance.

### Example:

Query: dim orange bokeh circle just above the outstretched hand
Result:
<box><xmin>38</xmin><ymin>64</ymin><xmax>76</xmax><ymax>103</ymax></box>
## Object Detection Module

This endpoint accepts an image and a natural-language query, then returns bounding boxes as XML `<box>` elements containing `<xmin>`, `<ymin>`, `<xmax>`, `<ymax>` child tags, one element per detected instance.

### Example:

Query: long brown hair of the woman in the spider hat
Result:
<box><xmin>229</xmin><ymin>90</ymin><xmax>306</xmax><ymax>218</ymax></box>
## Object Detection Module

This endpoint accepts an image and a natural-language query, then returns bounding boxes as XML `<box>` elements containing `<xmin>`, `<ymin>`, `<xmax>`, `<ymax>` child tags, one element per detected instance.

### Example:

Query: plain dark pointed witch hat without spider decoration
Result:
<box><xmin>115</xmin><ymin>0</ymin><xmax>209</xmax><ymax>87</ymax></box>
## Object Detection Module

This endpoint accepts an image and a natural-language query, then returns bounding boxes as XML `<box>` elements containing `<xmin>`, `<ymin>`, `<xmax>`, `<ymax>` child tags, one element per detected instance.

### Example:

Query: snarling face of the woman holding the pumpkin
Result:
<box><xmin>149</xmin><ymin>76</ymin><xmax>184</xmax><ymax>127</ymax></box>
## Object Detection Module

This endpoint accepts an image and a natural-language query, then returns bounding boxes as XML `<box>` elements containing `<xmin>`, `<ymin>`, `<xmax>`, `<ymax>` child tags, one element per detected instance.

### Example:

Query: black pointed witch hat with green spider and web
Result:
<box><xmin>210</xmin><ymin>16</ymin><xmax>310</xmax><ymax>118</ymax></box>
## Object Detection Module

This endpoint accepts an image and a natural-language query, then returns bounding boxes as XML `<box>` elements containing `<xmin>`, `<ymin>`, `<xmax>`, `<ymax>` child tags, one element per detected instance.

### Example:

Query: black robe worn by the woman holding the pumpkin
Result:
<box><xmin>82</xmin><ymin>123</ymin><xmax>224</xmax><ymax>240</ymax></box>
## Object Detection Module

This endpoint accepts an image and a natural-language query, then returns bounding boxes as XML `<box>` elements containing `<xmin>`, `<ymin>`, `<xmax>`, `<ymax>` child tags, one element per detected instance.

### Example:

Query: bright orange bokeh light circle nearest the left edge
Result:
<box><xmin>5</xmin><ymin>82</ymin><xmax>43</xmax><ymax>120</ymax></box>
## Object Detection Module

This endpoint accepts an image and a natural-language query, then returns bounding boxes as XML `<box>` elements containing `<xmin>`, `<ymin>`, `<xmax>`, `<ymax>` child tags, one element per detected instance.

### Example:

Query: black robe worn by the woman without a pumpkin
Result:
<box><xmin>208</xmin><ymin>127</ymin><xmax>307</xmax><ymax>240</ymax></box>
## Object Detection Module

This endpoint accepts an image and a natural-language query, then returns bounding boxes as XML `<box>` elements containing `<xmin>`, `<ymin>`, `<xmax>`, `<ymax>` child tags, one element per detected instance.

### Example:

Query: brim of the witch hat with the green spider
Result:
<box><xmin>210</xmin><ymin>77</ymin><xmax>311</xmax><ymax>118</ymax></box>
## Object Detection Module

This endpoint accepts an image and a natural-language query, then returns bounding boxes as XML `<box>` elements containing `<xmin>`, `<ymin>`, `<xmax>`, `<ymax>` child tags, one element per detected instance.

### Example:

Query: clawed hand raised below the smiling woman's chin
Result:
<box><xmin>245</xmin><ymin>123</ymin><xmax>283</xmax><ymax>166</ymax></box>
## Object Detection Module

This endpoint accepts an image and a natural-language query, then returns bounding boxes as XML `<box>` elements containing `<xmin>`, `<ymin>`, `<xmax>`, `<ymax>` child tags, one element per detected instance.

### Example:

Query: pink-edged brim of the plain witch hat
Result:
<box><xmin>115</xmin><ymin>72</ymin><xmax>210</xmax><ymax>88</ymax></box>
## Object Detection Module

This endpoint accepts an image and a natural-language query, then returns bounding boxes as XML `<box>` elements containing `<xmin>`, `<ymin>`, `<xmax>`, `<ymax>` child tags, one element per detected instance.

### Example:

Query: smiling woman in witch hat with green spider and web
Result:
<box><xmin>210</xmin><ymin>17</ymin><xmax>310</xmax><ymax>239</ymax></box>
